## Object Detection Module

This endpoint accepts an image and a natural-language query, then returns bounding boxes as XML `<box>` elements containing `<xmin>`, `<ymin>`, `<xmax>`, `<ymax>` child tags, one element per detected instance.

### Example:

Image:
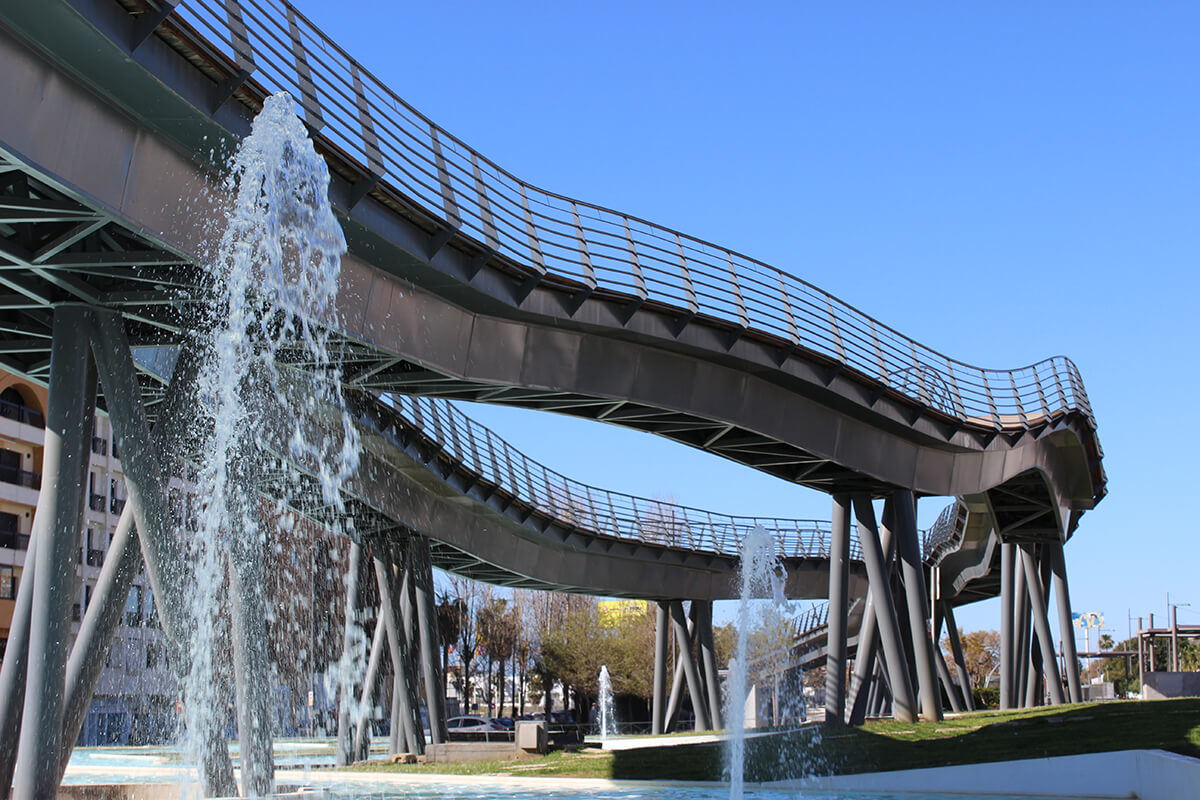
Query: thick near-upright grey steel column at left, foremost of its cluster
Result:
<box><xmin>13</xmin><ymin>306</ymin><xmax>96</xmax><ymax>800</ymax></box>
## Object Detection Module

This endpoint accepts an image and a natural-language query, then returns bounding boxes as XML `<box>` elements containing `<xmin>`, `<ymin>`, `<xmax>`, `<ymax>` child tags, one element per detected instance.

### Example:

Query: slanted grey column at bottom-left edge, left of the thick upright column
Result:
<box><xmin>0</xmin><ymin>531</ymin><xmax>35</xmax><ymax>800</ymax></box>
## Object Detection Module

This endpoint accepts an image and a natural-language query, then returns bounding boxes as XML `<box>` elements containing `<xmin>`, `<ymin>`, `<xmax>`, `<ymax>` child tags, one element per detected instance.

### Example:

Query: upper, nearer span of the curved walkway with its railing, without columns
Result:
<box><xmin>0</xmin><ymin>0</ymin><xmax>1105</xmax><ymax>554</ymax></box>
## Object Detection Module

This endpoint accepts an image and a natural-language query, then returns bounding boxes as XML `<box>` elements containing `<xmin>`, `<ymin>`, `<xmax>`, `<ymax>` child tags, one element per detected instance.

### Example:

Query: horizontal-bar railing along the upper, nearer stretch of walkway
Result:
<box><xmin>145</xmin><ymin>0</ymin><xmax>1094</xmax><ymax>429</ymax></box>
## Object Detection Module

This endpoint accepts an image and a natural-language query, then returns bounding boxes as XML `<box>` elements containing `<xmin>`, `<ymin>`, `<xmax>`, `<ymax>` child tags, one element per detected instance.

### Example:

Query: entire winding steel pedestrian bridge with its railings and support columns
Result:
<box><xmin>0</xmin><ymin>0</ymin><xmax>1106</xmax><ymax>782</ymax></box>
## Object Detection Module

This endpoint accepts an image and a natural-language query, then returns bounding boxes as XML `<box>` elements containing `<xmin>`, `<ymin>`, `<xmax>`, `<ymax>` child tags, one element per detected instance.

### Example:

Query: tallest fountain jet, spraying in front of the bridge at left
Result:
<box><xmin>184</xmin><ymin>94</ymin><xmax>358</xmax><ymax>795</ymax></box>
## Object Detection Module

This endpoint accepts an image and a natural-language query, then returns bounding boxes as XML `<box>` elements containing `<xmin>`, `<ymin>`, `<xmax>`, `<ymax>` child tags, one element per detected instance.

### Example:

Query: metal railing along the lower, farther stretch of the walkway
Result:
<box><xmin>380</xmin><ymin>393</ymin><xmax>862</xmax><ymax>559</ymax></box>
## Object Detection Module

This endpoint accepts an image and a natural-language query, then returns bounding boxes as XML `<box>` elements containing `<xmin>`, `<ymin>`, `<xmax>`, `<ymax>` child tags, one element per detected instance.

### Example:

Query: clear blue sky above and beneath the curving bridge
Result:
<box><xmin>299</xmin><ymin>0</ymin><xmax>1200</xmax><ymax>638</ymax></box>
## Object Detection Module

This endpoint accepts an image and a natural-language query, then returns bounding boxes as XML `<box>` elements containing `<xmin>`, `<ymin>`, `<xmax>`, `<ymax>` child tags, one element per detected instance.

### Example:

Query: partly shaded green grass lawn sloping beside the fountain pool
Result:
<box><xmin>350</xmin><ymin>699</ymin><xmax>1200</xmax><ymax>781</ymax></box>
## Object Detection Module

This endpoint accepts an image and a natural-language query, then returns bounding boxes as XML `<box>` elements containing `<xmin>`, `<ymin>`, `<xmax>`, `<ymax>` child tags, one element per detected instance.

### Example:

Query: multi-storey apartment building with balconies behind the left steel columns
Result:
<box><xmin>0</xmin><ymin>371</ymin><xmax>176</xmax><ymax>745</ymax></box>
